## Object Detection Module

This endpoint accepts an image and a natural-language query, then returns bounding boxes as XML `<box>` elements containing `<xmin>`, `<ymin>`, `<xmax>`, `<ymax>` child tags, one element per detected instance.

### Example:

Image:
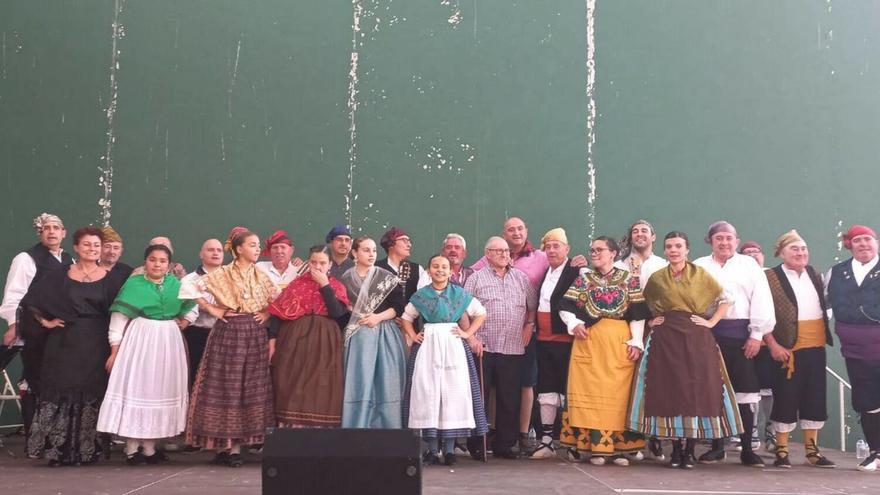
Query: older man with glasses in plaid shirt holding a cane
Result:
<box><xmin>464</xmin><ymin>237</ymin><xmax>549</xmax><ymax>459</ymax></box>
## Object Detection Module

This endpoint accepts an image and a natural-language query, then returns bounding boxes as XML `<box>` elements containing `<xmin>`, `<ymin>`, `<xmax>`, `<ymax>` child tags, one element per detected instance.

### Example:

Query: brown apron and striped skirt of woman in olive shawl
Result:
<box><xmin>627</xmin><ymin>311</ymin><xmax>743</xmax><ymax>439</ymax></box>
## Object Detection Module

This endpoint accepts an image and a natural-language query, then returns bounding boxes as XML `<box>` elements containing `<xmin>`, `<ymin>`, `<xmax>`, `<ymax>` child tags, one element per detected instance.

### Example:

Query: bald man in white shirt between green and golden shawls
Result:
<box><xmin>181</xmin><ymin>239</ymin><xmax>223</xmax><ymax>389</ymax></box>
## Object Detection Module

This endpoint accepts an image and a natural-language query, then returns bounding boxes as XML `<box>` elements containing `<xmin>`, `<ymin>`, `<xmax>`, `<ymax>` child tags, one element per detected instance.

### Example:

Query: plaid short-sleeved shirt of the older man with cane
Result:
<box><xmin>464</xmin><ymin>267</ymin><xmax>538</xmax><ymax>355</ymax></box>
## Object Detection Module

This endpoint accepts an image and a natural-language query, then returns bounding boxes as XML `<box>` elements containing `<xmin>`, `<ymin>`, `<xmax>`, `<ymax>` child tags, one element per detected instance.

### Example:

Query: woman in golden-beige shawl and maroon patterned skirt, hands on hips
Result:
<box><xmin>180</xmin><ymin>227</ymin><xmax>278</xmax><ymax>467</ymax></box>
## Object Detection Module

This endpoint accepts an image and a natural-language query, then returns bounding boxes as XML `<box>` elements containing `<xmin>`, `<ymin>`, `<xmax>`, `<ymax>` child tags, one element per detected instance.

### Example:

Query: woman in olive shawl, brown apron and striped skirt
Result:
<box><xmin>627</xmin><ymin>232</ymin><xmax>743</xmax><ymax>468</ymax></box>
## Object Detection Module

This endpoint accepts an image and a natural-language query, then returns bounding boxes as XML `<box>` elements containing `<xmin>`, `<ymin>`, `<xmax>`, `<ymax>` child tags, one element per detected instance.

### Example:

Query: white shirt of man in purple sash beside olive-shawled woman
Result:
<box><xmin>694</xmin><ymin>253</ymin><xmax>776</xmax><ymax>340</ymax></box>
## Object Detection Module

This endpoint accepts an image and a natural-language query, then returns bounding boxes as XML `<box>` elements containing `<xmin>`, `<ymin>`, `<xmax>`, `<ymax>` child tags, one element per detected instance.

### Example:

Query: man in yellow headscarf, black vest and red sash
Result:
<box><xmin>531</xmin><ymin>228</ymin><xmax>580</xmax><ymax>459</ymax></box>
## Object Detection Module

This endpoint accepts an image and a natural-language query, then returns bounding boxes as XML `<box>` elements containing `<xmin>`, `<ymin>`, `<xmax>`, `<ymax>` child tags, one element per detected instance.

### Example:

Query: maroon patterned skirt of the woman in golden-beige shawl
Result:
<box><xmin>186</xmin><ymin>315</ymin><xmax>275</xmax><ymax>449</ymax></box>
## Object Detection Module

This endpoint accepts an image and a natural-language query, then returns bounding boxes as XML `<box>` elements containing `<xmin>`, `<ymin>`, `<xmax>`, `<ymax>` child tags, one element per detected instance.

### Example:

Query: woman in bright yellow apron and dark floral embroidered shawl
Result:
<box><xmin>559</xmin><ymin>236</ymin><xmax>648</xmax><ymax>466</ymax></box>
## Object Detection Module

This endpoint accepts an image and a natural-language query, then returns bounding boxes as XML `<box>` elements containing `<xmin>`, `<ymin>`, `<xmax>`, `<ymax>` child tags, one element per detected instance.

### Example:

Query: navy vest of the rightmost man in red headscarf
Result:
<box><xmin>828</xmin><ymin>258</ymin><xmax>880</xmax><ymax>325</ymax></box>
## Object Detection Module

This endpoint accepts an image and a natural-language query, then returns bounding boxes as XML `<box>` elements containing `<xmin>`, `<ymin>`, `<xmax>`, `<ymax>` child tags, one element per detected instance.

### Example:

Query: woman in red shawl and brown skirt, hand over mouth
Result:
<box><xmin>269</xmin><ymin>245</ymin><xmax>349</xmax><ymax>428</ymax></box>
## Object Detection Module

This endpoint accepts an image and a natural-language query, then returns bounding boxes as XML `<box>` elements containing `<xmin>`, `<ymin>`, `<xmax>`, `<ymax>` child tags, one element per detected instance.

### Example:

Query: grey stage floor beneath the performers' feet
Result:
<box><xmin>0</xmin><ymin>436</ymin><xmax>880</xmax><ymax>495</ymax></box>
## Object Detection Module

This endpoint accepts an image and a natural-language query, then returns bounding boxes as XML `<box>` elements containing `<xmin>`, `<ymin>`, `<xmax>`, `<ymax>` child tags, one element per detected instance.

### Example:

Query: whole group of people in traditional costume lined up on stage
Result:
<box><xmin>0</xmin><ymin>214</ymin><xmax>880</xmax><ymax>471</ymax></box>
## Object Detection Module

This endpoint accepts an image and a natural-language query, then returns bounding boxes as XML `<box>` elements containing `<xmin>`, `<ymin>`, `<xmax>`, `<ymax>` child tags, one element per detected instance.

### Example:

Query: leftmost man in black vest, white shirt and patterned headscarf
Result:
<box><xmin>0</xmin><ymin>213</ymin><xmax>73</xmax><ymax>435</ymax></box>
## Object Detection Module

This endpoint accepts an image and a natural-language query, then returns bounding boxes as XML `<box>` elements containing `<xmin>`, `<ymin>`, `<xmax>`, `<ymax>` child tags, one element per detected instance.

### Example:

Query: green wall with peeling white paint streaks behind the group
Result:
<box><xmin>0</xmin><ymin>0</ymin><xmax>880</xmax><ymax>450</ymax></box>
